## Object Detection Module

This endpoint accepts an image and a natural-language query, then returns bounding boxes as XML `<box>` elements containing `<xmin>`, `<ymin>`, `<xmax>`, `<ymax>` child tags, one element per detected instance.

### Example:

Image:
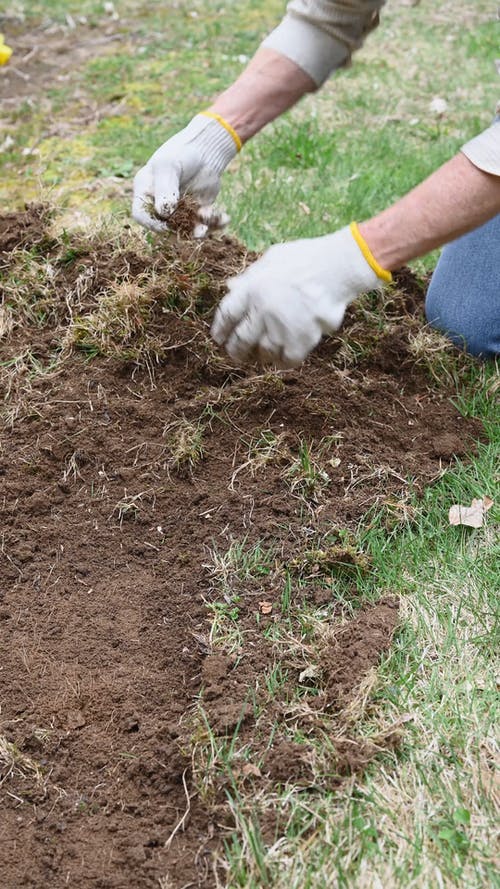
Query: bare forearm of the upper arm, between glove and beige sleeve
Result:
<box><xmin>209</xmin><ymin>48</ymin><xmax>316</xmax><ymax>142</ymax></box>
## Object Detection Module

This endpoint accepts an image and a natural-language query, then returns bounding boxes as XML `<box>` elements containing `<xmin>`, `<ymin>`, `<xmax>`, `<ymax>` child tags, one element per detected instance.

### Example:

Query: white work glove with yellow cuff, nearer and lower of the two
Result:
<box><xmin>212</xmin><ymin>223</ymin><xmax>391</xmax><ymax>367</ymax></box>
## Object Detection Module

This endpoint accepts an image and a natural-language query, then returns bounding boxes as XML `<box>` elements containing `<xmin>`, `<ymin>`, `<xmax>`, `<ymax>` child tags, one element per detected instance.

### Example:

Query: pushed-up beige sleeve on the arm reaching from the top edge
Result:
<box><xmin>262</xmin><ymin>0</ymin><xmax>385</xmax><ymax>87</ymax></box>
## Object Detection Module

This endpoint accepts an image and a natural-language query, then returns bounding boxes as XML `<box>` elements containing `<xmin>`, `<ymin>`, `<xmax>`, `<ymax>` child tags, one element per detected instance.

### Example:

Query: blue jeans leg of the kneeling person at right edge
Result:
<box><xmin>425</xmin><ymin>215</ymin><xmax>500</xmax><ymax>358</ymax></box>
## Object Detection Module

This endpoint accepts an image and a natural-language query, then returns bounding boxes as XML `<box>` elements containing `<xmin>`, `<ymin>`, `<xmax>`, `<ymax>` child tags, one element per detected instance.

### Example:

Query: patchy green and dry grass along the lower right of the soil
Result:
<box><xmin>209</xmin><ymin>369</ymin><xmax>500</xmax><ymax>889</ymax></box>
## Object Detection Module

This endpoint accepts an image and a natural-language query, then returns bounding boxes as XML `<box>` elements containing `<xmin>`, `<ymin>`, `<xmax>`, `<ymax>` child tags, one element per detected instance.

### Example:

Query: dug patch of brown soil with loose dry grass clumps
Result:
<box><xmin>0</xmin><ymin>208</ymin><xmax>481</xmax><ymax>889</ymax></box>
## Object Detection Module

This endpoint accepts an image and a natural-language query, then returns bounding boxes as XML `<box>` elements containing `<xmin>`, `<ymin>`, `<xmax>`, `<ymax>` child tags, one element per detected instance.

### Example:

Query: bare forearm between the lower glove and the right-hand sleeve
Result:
<box><xmin>359</xmin><ymin>153</ymin><xmax>500</xmax><ymax>270</ymax></box>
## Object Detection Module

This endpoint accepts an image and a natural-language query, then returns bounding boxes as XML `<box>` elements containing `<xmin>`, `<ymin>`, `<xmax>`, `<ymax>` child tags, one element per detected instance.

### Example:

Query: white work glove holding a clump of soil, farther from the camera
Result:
<box><xmin>132</xmin><ymin>113</ymin><xmax>241</xmax><ymax>237</ymax></box>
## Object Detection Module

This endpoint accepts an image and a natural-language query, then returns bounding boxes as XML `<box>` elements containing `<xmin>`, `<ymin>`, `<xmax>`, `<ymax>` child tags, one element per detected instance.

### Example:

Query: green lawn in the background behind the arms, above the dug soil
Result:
<box><xmin>0</xmin><ymin>0</ymin><xmax>498</xmax><ymax>248</ymax></box>
